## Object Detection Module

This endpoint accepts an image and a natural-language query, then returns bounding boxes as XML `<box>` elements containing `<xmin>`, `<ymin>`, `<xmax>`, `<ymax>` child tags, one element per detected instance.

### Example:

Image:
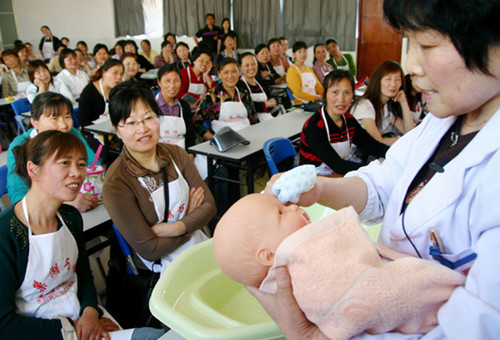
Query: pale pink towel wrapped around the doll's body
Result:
<box><xmin>260</xmin><ymin>207</ymin><xmax>465</xmax><ymax>339</ymax></box>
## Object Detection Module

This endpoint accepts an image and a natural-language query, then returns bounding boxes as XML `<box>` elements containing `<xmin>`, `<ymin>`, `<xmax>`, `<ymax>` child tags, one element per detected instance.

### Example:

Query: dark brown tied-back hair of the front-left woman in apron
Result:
<box><xmin>12</xmin><ymin>131</ymin><xmax>88</xmax><ymax>187</ymax></box>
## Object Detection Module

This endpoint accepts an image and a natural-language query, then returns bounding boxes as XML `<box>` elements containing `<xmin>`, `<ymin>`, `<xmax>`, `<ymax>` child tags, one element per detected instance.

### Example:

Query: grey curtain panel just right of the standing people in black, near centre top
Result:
<box><xmin>233</xmin><ymin>0</ymin><xmax>283</xmax><ymax>49</ymax></box>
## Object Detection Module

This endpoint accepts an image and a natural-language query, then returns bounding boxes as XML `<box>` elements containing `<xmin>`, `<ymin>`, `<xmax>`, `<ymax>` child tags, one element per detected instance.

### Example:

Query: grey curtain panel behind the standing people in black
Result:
<box><xmin>163</xmin><ymin>0</ymin><xmax>231</xmax><ymax>36</ymax></box>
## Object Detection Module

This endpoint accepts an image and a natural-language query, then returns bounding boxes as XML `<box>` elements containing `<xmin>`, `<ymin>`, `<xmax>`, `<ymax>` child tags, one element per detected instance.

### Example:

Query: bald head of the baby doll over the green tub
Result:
<box><xmin>214</xmin><ymin>194</ymin><xmax>310</xmax><ymax>287</ymax></box>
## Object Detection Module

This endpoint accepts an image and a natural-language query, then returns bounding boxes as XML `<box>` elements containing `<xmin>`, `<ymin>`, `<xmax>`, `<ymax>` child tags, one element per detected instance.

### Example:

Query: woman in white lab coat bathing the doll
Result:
<box><xmin>251</xmin><ymin>0</ymin><xmax>500</xmax><ymax>339</ymax></box>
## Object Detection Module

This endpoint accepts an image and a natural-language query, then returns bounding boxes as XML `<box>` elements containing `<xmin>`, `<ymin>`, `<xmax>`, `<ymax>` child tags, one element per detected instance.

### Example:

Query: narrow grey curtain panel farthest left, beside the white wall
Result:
<box><xmin>114</xmin><ymin>0</ymin><xmax>144</xmax><ymax>37</ymax></box>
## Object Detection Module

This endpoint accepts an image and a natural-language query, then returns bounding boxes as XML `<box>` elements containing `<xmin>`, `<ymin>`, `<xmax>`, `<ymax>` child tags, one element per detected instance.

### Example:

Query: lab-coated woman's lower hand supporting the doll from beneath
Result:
<box><xmin>246</xmin><ymin>267</ymin><xmax>327</xmax><ymax>340</ymax></box>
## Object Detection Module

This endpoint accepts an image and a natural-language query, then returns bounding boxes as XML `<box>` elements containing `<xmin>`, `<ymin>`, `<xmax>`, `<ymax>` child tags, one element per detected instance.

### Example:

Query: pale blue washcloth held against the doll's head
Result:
<box><xmin>273</xmin><ymin>165</ymin><xmax>316</xmax><ymax>204</ymax></box>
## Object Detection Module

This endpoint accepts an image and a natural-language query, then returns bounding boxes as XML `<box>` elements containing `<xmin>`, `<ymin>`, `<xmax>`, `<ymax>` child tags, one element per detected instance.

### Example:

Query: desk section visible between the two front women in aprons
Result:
<box><xmin>82</xmin><ymin>204</ymin><xmax>113</xmax><ymax>255</ymax></box>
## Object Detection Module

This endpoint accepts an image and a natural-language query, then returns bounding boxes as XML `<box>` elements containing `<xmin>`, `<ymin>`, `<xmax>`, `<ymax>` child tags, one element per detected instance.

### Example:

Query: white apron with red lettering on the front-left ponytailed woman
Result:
<box><xmin>16</xmin><ymin>197</ymin><xmax>80</xmax><ymax>320</ymax></box>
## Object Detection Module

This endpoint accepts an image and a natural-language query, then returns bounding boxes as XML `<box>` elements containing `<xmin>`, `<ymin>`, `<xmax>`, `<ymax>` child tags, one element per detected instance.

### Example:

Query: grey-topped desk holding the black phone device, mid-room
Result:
<box><xmin>188</xmin><ymin>110</ymin><xmax>312</xmax><ymax>193</ymax></box>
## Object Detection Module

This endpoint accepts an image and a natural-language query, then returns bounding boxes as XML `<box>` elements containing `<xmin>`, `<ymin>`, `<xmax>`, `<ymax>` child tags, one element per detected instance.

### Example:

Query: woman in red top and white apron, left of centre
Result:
<box><xmin>178</xmin><ymin>49</ymin><xmax>217</xmax><ymax>109</ymax></box>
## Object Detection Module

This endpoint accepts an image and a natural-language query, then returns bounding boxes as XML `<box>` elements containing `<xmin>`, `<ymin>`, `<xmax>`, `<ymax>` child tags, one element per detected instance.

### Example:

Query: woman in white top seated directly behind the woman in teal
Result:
<box><xmin>26</xmin><ymin>60</ymin><xmax>76</xmax><ymax>103</ymax></box>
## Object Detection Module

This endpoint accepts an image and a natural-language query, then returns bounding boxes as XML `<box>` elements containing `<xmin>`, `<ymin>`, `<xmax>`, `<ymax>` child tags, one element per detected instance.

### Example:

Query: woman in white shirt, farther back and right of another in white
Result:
<box><xmin>56</xmin><ymin>48</ymin><xmax>89</xmax><ymax>100</ymax></box>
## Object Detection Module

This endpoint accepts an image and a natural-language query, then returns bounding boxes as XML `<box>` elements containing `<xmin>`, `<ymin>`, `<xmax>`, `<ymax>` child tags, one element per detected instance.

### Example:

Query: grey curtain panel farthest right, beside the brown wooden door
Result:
<box><xmin>283</xmin><ymin>0</ymin><xmax>357</xmax><ymax>51</ymax></box>
